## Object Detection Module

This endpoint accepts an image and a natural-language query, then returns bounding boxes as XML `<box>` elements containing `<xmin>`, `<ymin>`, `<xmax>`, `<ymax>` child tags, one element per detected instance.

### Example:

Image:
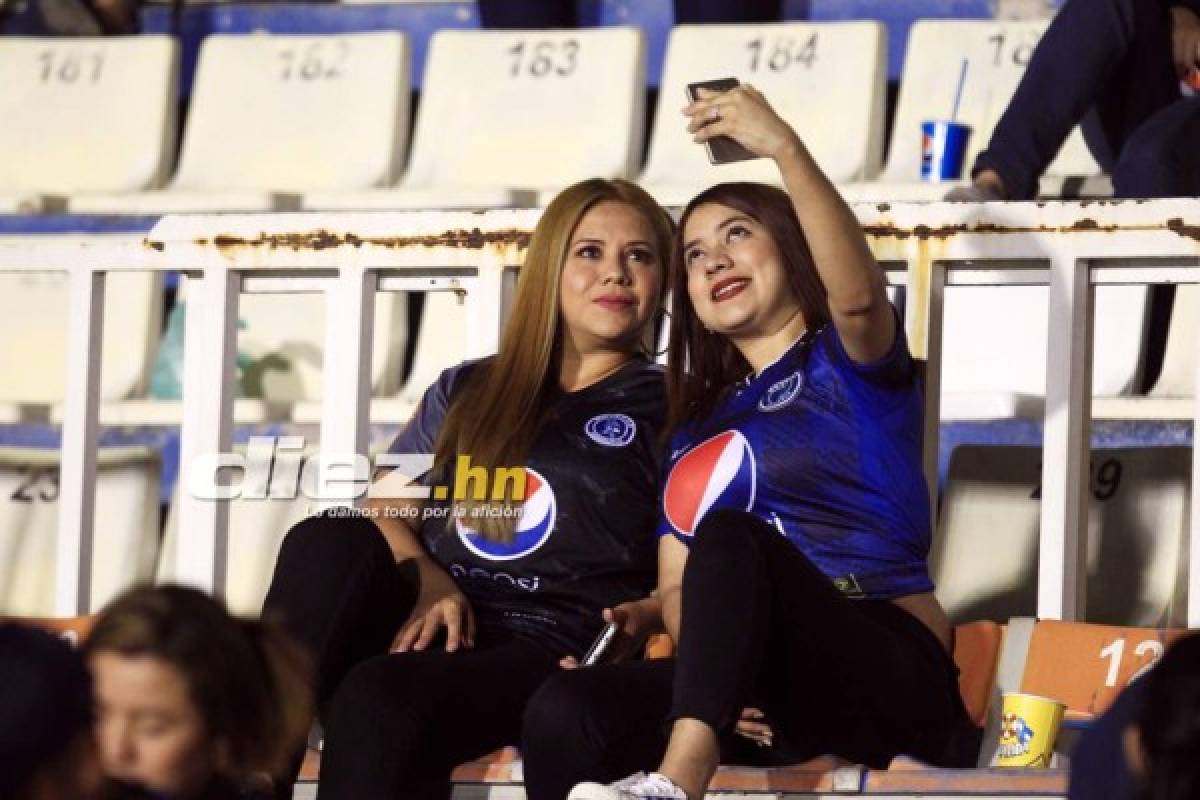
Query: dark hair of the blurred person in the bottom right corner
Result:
<box><xmin>1138</xmin><ymin>633</ymin><xmax>1200</xmax><ymax>800</ymax></box>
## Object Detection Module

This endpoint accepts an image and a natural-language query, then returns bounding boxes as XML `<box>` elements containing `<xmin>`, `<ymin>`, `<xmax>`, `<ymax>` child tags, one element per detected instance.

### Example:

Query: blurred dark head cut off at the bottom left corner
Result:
<box><xmin>0</xmin><ymin>624</ymin><xmax>100</xmax><ymax>800</ymax></box>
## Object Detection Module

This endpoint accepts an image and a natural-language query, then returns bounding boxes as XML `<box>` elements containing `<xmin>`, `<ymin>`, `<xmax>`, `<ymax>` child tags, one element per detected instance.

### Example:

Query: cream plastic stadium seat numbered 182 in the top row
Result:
<box><xmin>70</xmin><ymin>31</ymin><xmax>409</xmax><ymax>213</ymax></box>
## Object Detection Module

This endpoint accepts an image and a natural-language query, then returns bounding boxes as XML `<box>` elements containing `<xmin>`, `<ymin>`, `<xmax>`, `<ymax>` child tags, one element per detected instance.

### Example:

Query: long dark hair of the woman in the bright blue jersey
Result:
<box><xmin>667</xmin><ymin>182</ymin><xmax>829</xmax><ymax>431</ymax></box>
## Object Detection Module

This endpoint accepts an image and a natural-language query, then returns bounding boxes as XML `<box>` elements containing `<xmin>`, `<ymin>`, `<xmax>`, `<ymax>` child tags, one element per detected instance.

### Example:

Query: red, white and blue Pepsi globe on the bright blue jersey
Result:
<box><xmin>662</xmin><ymin>431</ymin><xmax>756</xmax><ymax>536</ymax></box>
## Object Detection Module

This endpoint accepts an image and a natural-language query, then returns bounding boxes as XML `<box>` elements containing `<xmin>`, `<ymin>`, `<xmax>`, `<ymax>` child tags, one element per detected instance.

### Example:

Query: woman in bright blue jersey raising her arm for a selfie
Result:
<box><xmin>523</xmin><ymin>86</ymin><xmax>978</xmax><ymax>800</ymax></box>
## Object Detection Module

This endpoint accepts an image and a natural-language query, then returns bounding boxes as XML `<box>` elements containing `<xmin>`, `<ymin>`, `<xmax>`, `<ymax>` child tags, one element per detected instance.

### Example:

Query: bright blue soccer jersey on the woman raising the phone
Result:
<box><xmin>658</xmin><ymin>314</ymin><xmax>932</xmax><ymax>597</ymax></box>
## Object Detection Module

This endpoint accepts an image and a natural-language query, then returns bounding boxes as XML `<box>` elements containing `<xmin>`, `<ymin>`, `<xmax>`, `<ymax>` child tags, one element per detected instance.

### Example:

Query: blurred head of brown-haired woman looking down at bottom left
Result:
<box><xmin>83</xmin><ymin>587</ymin><xmax>311</xmax><ymax>799</ymax></box>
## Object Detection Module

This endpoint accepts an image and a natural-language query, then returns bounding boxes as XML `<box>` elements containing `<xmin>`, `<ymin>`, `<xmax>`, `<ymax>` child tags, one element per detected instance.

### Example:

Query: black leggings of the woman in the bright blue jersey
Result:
<box><xmin>522</xmin><ymin>511</ymin><xmax>979</xmax><ymax>800</ymax></box>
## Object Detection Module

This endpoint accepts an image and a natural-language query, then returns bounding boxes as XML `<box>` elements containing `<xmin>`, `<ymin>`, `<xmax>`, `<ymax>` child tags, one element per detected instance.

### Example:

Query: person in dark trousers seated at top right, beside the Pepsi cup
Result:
<box><xmin>946</xmin><ymin>0</ymin><xmax>1200</xmax><ymax>201</ymax></box>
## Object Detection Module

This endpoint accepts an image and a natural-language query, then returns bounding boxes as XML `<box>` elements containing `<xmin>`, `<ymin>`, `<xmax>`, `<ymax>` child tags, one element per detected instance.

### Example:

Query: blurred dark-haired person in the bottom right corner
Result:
<box><xmin>1067</xmin><ymin>633</ymin><xmax>1200</xmax><ymax>800</ymax></box>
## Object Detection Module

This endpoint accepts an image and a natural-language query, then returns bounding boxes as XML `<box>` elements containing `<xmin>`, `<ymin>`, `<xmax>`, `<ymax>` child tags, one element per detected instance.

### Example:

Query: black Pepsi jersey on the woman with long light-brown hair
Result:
<box><xmin>389</xmin><ymin>360</ymin><xmax>666</xmax><ymax>656</ymax></box>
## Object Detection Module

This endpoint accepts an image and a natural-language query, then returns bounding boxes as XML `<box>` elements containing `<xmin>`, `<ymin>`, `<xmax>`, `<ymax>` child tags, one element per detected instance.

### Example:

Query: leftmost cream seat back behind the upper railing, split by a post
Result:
<box><xmin>0</xmin><ymin>255</ymin><xmax>162</xmax><ymax>404</ymax></box>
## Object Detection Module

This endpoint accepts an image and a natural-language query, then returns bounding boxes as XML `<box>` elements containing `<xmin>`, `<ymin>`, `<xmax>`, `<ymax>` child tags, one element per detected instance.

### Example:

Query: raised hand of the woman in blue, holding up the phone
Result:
<box><xmin>683</xmin><ymin>84</ymin><xmax>804</xmax><ymax>160</ymax></box>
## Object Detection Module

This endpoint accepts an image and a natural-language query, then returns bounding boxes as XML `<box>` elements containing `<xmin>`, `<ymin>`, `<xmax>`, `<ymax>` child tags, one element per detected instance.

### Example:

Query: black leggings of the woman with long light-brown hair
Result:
<box><xmin>263</xmin><ymin>517</ymin><xmax>558</xmax><ymax>800</ymax></box>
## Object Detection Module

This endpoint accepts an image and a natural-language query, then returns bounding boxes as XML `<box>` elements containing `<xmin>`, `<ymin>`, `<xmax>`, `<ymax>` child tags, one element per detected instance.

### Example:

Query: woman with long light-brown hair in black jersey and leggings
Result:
<box><xmin>265</xmin><ymin>180</ymin><xmax>673</xmax><ymax>800</ymax></box>
